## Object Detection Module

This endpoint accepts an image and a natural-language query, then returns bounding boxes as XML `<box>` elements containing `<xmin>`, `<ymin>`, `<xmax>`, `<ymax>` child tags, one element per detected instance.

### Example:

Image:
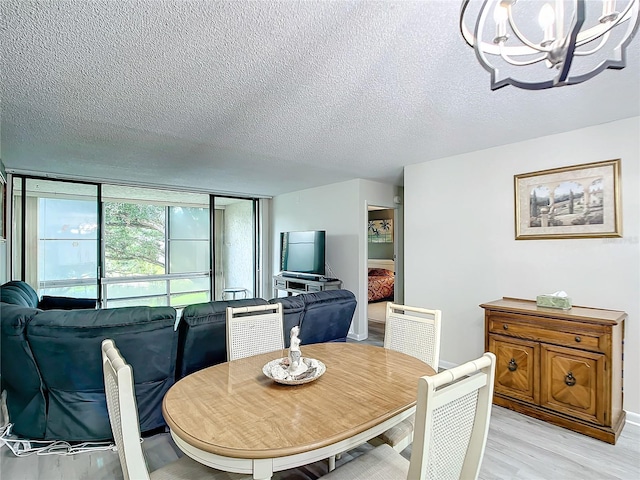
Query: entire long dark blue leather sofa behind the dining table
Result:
<box><xmin>0</xmin><ymin>282</ymin><xmax>356</xmax><ymax>442</ymax></box>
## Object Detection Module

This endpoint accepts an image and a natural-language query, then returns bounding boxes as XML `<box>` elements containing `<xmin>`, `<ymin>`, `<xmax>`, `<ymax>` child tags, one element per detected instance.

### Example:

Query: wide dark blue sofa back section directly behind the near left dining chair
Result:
<box><xmin>27</xmin><ymin>307</ymin><xmax>177</xmax><ymax>441</ymax></box>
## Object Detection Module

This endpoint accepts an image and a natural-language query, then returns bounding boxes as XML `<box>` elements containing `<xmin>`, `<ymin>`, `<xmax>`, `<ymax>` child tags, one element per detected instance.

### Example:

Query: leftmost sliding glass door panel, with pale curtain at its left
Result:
<box><xmin>13</xmin><ymin>178</ymin><xmax>100</xmax><ymax>299</ymax></box>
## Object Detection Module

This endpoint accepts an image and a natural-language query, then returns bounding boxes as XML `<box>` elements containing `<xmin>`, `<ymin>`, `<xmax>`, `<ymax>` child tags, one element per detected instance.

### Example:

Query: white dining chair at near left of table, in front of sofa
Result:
<box><xmin>102</xmin><ymin>339</ymin><xmax>252</xmax><ymax>480</ymax></box>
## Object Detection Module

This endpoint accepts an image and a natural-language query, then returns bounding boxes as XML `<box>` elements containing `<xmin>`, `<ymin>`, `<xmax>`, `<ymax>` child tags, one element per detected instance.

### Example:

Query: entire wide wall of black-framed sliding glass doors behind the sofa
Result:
<box><xmin>12</xmin><ymin>177</ymin><xmax>259</xmax><ymax>308</ymax></box>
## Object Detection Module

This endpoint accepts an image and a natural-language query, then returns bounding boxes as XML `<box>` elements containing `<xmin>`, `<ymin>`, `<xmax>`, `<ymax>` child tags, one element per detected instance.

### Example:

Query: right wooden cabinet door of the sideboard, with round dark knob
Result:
<box><xmin>540</xmin><ymin>344</ymin><xmax>611</xmax><ymax>425</ymax></box>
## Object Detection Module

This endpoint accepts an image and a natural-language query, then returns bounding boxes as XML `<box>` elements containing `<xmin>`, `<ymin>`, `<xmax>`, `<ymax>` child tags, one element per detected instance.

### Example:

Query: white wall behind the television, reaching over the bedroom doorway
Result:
<box><xmin>267</xmin><ymin>179</ymin><xmax>396</xmax><ymax>340</ymax></box>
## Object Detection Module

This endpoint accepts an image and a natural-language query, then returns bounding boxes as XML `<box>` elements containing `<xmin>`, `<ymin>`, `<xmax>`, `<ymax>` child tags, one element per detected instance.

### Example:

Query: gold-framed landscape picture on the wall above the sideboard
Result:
<box><xmin>514</xmin><ymin>159</ymin><xmax>622</xmax><ymax>240</ymax></box>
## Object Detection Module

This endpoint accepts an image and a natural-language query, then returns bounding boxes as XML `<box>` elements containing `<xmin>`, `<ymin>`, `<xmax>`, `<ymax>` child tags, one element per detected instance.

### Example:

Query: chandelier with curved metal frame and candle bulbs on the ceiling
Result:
<box><xmin>460</xmin><ymin>0</ymin><xmax>640</xmax><ymax>90</ymax></box>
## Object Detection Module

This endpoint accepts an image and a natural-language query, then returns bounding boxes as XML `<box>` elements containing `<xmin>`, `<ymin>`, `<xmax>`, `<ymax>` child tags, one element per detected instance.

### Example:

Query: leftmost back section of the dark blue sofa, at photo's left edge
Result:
<box><xmin>0</xmin><ymin>303</ymin><xmax>46</xmax><ymax>438</ymax></box>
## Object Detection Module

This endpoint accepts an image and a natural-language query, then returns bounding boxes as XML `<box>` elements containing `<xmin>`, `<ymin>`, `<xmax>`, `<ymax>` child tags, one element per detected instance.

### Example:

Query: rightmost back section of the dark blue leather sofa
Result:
<box><xmin>300</xmin><ymin>290</ymin><xmax>357</xmax><ymax>345</ymax></box>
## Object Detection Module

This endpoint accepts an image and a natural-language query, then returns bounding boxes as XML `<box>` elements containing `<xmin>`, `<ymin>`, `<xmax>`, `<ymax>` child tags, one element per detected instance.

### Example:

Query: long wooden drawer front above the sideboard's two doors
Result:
<box><xmin>489</xmin><ymin>318</ymin><xmax>600</xmax><ymax>352</ymax></box>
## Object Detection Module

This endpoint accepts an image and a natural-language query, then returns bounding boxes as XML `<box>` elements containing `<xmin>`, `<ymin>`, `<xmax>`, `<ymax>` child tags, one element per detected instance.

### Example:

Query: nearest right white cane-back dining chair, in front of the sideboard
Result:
<box><xmin>321</xmin><ymin>352</ymin><xmax>496</xmax><ymax>480</ymax></box>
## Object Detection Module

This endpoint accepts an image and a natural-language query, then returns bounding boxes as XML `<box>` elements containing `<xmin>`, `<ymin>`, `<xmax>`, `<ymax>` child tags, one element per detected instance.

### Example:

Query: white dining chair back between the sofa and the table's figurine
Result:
<box><xmin>227</xmin><ymin>303</ymin><xmax>284</xmax><ymax>361</ymax></box>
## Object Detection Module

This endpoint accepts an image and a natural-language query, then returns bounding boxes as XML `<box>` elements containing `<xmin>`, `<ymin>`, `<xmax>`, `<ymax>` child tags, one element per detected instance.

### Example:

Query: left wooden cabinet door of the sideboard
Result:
<box><xmin>489</xmin><ymin>335</ymin><xmax>540</xmax><ymax>403</ymax></box>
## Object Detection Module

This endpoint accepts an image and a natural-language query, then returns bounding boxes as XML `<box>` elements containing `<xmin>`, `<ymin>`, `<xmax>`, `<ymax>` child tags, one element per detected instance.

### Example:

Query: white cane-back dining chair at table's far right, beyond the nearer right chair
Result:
<box><xmin>370</xmin><ymin>303</ymin><xmax>442</xmax><ymax>452</ymax></box>
